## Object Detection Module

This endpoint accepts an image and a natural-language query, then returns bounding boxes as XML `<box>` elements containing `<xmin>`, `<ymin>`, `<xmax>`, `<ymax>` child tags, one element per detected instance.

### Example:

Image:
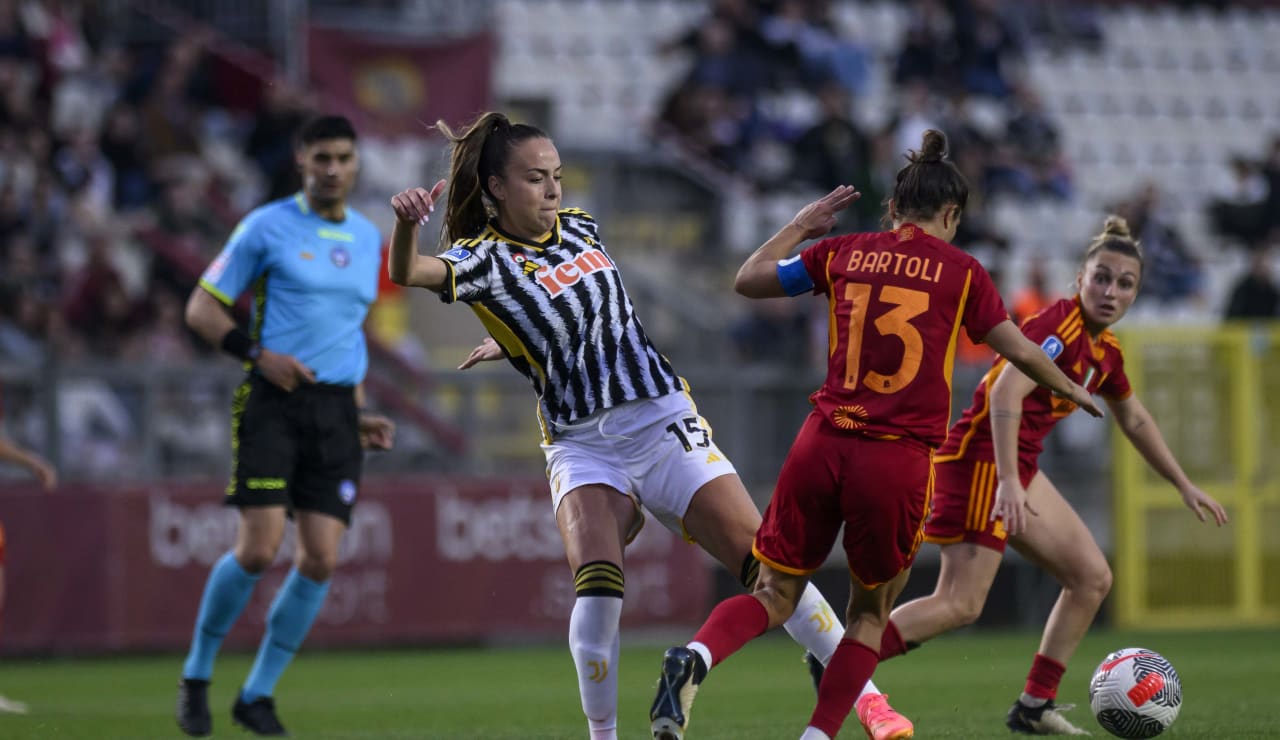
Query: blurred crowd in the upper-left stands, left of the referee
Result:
<box><xmin>0</xmin><ymin>0</ymin><xmax>308</xmax><ymax>366</ymax></box>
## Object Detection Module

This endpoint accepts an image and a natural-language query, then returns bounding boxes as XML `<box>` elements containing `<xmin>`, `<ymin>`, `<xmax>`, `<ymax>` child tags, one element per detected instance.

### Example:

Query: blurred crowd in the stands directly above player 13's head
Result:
<box><xmin>659</xmin><ymin>0</ymin><xmax>1101</xmax><ymax>214</ymax></box>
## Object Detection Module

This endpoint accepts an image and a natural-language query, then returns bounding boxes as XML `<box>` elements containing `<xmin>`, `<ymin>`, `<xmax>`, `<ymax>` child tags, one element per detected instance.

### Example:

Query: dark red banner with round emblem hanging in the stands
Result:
<box><xmin>307</xmin><ymin>26</ymin><xmax>494</xmax><ymax>136</ymax></box>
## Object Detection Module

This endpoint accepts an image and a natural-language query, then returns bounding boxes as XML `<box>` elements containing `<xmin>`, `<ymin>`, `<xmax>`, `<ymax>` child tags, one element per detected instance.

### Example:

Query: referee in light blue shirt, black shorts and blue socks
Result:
<box><xmin>177</xmin><ymin>115</ymin><xmax>394</xmax><ymax>736</ymax></box>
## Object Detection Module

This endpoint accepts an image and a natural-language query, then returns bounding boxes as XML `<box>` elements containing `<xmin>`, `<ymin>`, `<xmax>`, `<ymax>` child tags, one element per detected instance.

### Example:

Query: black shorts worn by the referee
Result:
<box><xmin>227</xmin><ymin>375</ymin><xmax>364</xmax><ymax>524</ymax></box>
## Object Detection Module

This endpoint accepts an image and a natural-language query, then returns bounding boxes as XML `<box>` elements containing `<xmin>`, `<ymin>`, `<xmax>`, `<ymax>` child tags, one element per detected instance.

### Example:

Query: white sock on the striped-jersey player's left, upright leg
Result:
<box><xmin>568</xmin><ymin>597</ymin><xmax>622</xmax><ymax>740</ymax></box>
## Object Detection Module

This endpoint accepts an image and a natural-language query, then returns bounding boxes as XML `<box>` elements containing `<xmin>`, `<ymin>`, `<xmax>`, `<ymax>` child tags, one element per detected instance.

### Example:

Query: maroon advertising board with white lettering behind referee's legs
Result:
<box><xmin>0</xmin><ymin>479</ymin><xmax>710</xmax><ymax>653</ymax></box>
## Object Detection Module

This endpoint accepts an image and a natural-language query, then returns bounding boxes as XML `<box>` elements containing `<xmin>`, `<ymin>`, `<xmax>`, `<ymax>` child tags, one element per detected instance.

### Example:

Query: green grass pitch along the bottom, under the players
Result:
<box><xmin>0</xmin><ymin>631</ymin><xmax>1280</xmax><ymax>740</ymax></box>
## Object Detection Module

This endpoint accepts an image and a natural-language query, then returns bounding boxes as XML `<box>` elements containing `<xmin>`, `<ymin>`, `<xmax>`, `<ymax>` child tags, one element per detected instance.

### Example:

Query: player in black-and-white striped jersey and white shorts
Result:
<box><xmin>388</xmin><ymin>113</ymin><xmax>860</xmax><ymax>739</ymax></box>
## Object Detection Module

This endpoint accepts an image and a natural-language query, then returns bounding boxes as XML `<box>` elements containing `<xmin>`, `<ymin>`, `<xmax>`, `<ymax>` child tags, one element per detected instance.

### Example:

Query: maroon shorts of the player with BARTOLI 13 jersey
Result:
<box><xmin>751</xmin><ymin>412</ymin><xmax>933</xmax><ymax>588</ymax></box>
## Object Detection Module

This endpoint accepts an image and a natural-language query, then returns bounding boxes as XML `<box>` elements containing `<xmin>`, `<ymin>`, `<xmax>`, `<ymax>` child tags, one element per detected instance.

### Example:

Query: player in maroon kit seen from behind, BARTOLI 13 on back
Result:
<box><xmin>650</xmin><ymin>129</ymin><xmax>1101</xmax><ymax>740</ymax></box>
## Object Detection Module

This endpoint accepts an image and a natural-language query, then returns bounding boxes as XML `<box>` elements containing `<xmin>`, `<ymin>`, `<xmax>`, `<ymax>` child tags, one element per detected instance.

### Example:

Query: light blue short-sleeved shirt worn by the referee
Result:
<box><xmin>200</xmin><ymin>193</ymin><xmax>381</xmax><ymax>385</ymax></box>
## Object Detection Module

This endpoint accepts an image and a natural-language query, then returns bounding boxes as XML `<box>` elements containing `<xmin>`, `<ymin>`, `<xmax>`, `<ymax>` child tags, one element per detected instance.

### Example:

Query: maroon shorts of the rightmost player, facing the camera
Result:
<box><xmin>924</xmin><ymin>458</ymin><xmax>1037</xmax><ymax>552</ymax></box>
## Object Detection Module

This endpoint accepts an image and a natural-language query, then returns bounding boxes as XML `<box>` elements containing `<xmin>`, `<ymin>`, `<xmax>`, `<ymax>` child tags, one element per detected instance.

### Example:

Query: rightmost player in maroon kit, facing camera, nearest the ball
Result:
<box><xmin>881</xmin><ymin>216</ymin><xmax>1226</xmax><ymax>735</ymax></box>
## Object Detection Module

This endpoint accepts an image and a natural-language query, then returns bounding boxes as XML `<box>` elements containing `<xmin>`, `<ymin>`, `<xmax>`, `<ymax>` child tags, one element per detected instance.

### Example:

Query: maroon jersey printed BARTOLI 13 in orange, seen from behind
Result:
<box><xmin>778</xmin><ymin>224</ymin><xmax>1009</xmax><ymax>448</ymax></box>
